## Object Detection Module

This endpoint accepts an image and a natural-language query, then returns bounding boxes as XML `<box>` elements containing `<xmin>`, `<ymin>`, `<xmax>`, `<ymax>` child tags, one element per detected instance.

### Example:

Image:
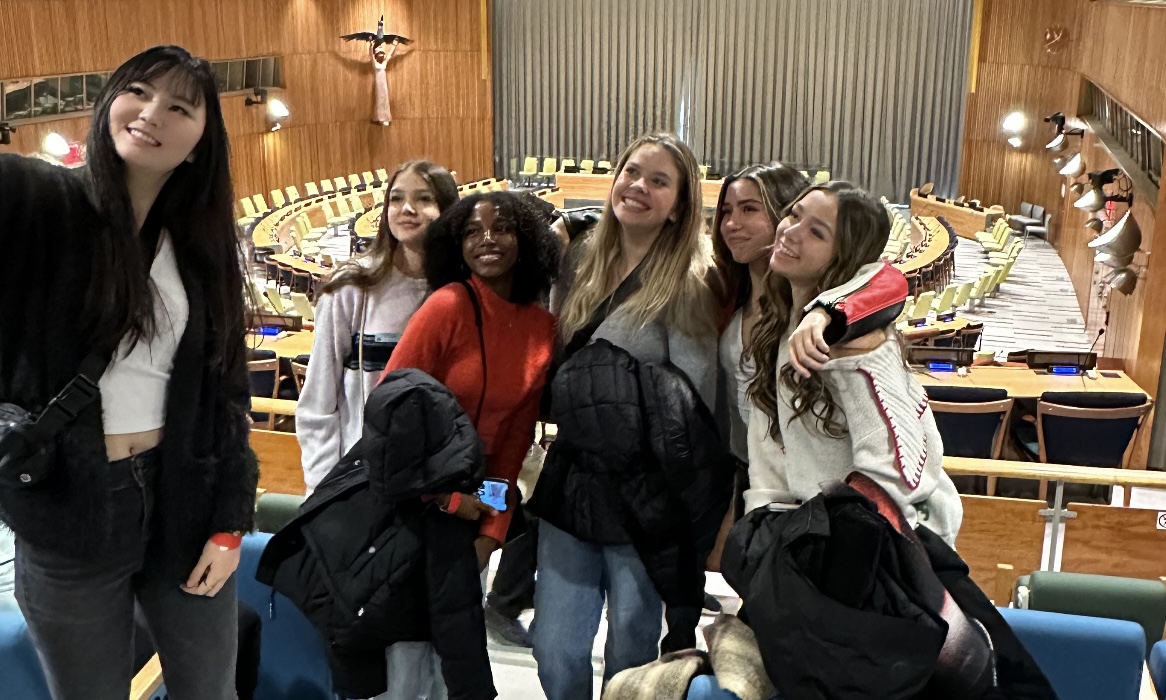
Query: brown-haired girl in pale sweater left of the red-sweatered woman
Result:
<box><xmin>295</xmin><ymin>161</ymin><xmax>458</xmax><ymax>494</ymax></box>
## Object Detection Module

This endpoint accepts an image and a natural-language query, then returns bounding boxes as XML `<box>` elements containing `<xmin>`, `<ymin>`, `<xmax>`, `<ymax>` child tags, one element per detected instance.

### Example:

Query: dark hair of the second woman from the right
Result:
<box><xmin>712</xmin><ymin>161</ymin><xmax>809</xmax><ymax>309</ymax></box>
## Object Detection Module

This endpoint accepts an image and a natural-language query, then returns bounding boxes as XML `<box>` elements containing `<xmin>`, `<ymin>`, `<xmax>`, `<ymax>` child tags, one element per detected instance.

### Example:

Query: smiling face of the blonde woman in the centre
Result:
<box><xmin>611</xmin><ymin>144</ymin><xmax>683</xmax><ymax>232</ymax></box>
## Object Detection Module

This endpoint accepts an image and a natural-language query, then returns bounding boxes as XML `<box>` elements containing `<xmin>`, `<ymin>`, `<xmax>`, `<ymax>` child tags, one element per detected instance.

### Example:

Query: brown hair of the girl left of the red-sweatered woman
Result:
<box><xmin>319</xmin><ymin>161</ymin><xmax>458</xmax><ymax>294</ymax></box>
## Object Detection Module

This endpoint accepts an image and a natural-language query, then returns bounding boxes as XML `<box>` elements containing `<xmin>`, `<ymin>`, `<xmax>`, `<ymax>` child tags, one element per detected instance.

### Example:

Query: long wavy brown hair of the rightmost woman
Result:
<box><xmin>749</xmin><ymin>181</ymin><xmax>891</xmax><ymax>440</ymax></box>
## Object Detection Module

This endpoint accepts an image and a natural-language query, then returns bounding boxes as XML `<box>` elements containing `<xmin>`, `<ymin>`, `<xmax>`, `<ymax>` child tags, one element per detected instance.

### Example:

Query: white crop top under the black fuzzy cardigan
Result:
<box><xmin>98</xmin><ymin>231</ymin><xmax>190</xmax><ymax>435</ymax></box>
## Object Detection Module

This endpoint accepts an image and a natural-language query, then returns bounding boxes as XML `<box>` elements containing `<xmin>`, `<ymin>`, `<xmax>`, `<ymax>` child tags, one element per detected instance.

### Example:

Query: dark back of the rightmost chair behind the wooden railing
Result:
<box><xmin>1037</xmin><ymin>391</ymin><xmax>1153</xmax><ymax>468</ymax></box>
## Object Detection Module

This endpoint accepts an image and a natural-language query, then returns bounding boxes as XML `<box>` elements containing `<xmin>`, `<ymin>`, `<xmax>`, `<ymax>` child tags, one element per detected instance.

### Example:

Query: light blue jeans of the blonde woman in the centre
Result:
<box><xmin>532</xmin><ymin>520</ymin><xmax>663</xmax><ymax>700</ymax></box>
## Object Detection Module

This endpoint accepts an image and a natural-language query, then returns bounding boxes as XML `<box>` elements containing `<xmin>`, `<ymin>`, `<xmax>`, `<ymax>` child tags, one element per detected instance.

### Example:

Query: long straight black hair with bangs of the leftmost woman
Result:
<box><xmin>86</xmin><ymin>46</ymin><xmax>245</xmax><ymax>366</ymax></box>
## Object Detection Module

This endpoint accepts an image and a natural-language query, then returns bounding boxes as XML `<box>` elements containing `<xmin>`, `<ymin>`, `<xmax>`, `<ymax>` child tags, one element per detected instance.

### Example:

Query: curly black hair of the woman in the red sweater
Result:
<box><xmin>426</xmin><ymin>191</ymin><xmax>562</xmax><ymax>303</ymax></box>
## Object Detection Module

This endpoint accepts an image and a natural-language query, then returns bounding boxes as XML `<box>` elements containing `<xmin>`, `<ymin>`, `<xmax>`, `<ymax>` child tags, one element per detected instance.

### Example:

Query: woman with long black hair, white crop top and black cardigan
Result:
<box><xmin>0</xmin><ymin>47</ymin><xmax>257</xmax><ymax>700</ymax></box>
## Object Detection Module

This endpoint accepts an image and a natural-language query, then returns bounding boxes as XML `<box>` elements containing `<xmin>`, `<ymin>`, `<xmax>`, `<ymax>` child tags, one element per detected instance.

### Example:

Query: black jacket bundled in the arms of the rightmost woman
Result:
<box><xmin>722</xmin><ymin>475</ymin><xmax>1055</xmax><ymax>700</ymax></box>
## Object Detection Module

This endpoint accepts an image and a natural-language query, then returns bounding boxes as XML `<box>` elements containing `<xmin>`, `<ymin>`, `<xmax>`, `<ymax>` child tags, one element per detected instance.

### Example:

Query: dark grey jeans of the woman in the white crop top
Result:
<box><xmin>16</xmin><ymin>449</ymin><xmax>239</xmax><ymax>700</ymax></box>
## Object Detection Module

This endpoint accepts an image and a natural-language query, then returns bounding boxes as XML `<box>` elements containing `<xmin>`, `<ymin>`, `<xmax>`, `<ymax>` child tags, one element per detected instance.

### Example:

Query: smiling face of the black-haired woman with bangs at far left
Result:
<box><xmin>110</xmin><ymin>71</ymin><xmax>206</xmax><ymax>175</ymax></box>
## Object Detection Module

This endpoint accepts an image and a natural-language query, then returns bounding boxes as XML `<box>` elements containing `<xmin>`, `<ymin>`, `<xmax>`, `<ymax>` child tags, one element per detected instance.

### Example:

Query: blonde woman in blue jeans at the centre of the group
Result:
<box><xmin>531</xmin><ymin>134</ymin><xmax>728</xmax><ymax>700</ymax></box>
